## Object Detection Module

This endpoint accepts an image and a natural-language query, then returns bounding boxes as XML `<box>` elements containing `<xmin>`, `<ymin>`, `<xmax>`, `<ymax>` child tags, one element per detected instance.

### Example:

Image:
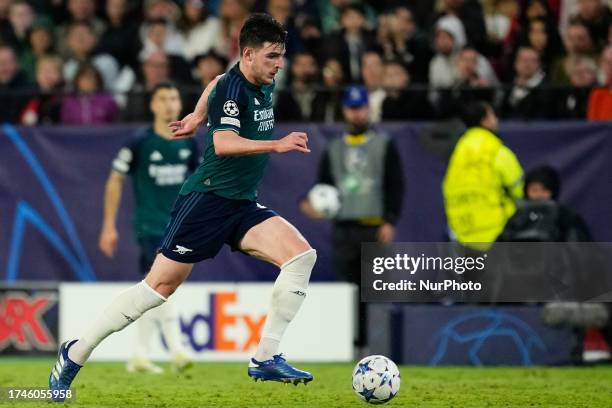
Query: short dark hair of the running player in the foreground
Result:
<box><xmin>240</xmin><ymin>13</ymin><xmax>287</xmax><ymax>55</ymax></box>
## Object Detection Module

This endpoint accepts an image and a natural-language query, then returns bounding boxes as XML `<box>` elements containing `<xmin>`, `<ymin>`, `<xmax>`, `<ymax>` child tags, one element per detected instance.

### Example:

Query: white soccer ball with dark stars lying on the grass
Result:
<box><xmin>353</xmin><ymin>356</ymin><xmax>400</xmax><ymax>404</ymax></box>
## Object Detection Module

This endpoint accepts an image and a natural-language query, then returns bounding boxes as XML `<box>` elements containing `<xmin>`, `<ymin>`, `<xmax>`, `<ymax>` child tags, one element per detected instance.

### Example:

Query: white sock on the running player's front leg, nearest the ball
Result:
<box><xmin>255</xmin><ymin>249</ymin><xmax>317</xmax><ymax>361</ymax></box>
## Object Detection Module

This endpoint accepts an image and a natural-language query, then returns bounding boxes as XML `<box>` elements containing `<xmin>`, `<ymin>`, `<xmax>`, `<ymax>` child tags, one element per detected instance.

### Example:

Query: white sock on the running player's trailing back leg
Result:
<box><xmin>68</xmin><ymin>280</ymin><xmax>166</xmax><ymax>365</ymax></box>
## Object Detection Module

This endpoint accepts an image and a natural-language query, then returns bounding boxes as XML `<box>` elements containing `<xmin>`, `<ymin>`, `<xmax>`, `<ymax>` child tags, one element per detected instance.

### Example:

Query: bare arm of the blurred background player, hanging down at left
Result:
<box><xmin>98</xmin><ymin>170</ymin><xmax>125</xmax><ymax>258</ymax></box>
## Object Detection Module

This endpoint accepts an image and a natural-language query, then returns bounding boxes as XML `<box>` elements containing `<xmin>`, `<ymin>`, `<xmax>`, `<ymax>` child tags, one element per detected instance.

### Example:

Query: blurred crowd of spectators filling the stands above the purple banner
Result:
<box><xmin>0</xmin><ymin>0</ymin><xmax>612</xmax><ymax>125</ymax></box>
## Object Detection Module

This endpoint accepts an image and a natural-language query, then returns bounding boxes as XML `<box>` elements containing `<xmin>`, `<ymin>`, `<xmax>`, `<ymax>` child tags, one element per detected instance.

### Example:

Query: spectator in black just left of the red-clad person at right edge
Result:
<box><xmin>555</xmin><ymin>57</ymin><xmax>597</xmax><ymax>120</ymax></box>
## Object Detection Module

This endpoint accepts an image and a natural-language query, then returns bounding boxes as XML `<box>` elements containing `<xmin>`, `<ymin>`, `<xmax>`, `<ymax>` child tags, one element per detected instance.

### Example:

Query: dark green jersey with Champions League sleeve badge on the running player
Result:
<box><xmin>181</xmin><ymin>64</ymin><xmax>274</xmax><ymax>201</ymax></box>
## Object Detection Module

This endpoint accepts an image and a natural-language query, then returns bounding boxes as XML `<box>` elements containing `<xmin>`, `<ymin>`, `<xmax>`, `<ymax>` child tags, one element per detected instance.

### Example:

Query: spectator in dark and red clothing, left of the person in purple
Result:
<box><xmin>19</xmin><ymin>55</ymin><xmax>64</xmax><ymax>126</ymax></box>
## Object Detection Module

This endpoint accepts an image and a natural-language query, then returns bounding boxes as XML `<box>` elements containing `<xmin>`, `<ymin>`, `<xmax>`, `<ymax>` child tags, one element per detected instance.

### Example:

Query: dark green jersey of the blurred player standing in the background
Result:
<box><xmin>113</xmin><ymin>128</ymin><xmax>198</xmax><ymax>238</ymax></box>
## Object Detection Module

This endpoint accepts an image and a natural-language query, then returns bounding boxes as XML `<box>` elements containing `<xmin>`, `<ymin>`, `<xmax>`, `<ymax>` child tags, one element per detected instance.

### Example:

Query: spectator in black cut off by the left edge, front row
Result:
<box><xmin>0</xmin><ymin>44</ymin><xmax>29</xmax><ymax>123</ymax></box>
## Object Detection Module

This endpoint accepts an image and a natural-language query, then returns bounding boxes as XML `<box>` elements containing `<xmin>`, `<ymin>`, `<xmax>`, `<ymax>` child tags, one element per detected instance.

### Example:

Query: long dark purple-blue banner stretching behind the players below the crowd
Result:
<box><xmin>0</xmin><ymin>122</ymin><xmax>612</xmax><ymax>282</ymax></box>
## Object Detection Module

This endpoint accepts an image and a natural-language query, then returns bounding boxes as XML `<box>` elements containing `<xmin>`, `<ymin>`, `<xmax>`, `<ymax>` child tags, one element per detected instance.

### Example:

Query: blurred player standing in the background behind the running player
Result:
<box><xmin>99</xmin><ymin>82</ymin><xmax>198</xmax><ymax>374</ymax></box>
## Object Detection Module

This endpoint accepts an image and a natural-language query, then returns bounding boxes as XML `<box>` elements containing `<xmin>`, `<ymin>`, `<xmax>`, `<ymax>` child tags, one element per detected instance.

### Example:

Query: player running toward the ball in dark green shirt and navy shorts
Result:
<box><xmin>49</xmin><ymin>14</ymin><xmax>316</xmax><ymax>398</ymax></box>
